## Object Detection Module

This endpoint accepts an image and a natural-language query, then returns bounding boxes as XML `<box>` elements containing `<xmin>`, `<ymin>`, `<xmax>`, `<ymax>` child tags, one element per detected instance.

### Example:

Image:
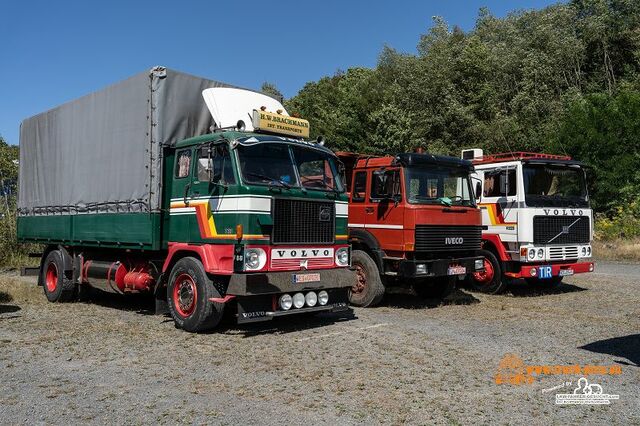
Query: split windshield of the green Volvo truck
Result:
<box><xmin>237</xmin><ymin>143</ymin><xmax>343</xmax><ymax>192</ymax></box>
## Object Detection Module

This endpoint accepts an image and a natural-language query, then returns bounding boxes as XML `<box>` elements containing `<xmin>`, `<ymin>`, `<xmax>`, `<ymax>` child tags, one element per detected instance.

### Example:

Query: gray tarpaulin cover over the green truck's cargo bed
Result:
<box><xmin>18</xmin><ymin>67</ymin><xmax>238</xmax><ymax>215</ymax></box>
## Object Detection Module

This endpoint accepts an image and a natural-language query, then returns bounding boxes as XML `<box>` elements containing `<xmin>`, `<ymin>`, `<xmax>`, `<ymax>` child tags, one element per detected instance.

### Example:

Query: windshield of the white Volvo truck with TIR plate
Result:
<box><xmin>523</xmin><ymin>164</ymin><xmax>589</xmax><ymax>207</ymax></box>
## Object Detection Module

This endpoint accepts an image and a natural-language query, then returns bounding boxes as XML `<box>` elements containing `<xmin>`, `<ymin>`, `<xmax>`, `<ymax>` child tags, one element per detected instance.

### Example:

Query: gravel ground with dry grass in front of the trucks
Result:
<box><xmin>0</xmin><ymin>263</ymin><xmax>640</xmax><ymax>424</ymax></box>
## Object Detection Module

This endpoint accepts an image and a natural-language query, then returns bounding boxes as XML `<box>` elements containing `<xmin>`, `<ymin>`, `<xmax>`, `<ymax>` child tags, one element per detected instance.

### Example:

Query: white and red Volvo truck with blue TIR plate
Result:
<box><xmin>462</xmin><ymin>149</ymin><xmax>594</xmax><ymax>293</ymax></box>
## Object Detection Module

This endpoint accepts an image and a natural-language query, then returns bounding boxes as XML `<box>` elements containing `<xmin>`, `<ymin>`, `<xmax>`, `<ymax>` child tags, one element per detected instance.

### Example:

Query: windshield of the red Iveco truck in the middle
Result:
<box><xmin>405</xmin><ymin>167</ymin><xmax>475</xmax><ymax>207</ymax></box>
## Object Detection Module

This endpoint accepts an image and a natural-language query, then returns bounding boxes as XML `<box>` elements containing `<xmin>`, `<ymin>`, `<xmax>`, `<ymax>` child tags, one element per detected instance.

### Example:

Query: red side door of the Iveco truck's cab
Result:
<box><xmin>364</xmin><ymin>168</ymin><xmax>404</xmax><ymax>252</ymax></box>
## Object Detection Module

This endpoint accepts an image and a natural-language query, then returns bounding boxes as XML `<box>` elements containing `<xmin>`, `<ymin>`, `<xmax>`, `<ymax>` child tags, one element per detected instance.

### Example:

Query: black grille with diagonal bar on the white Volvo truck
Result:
<box><xmin>533</xmin><ymin>216</ymin><xmax>590</xmax><ymax>244</ymax></box>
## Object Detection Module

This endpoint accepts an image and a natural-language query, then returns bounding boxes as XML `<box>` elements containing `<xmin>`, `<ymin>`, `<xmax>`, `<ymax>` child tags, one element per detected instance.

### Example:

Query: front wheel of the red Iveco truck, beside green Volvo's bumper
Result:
<box><xmin>349</xmin><ymin>250</ymin><xmax>384</xmax><ymax>307</ymax></box>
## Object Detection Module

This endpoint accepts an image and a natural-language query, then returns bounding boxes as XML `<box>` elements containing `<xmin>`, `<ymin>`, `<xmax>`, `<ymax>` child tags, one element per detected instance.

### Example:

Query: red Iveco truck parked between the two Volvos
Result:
<box><xmin>337</xmin><ymin>152</ymin><xmax>484</xmax><ymax>306</ymax></box>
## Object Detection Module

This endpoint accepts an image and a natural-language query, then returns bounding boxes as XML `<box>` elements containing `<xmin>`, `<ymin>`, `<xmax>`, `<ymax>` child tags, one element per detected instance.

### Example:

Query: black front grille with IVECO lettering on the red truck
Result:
<box><xmin>416</xmin><ymin>225</ymin><xmax>482</xmax><ymax>251</ymax></box>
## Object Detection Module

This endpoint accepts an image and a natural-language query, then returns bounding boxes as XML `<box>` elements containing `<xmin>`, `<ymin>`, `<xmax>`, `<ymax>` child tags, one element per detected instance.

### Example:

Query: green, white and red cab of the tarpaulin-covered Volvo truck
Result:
<box><xmin>163</xmin><ymin>131</ymin><xmax>352</xmax><ymax>330</ymax></box>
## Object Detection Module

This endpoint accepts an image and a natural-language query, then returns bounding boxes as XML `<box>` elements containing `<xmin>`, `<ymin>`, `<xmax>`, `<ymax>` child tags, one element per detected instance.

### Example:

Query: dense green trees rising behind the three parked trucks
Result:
<box><xmin>286</xmin><ymin>0</ymin><xmax>640</xmax><ymax>220</ymax></box>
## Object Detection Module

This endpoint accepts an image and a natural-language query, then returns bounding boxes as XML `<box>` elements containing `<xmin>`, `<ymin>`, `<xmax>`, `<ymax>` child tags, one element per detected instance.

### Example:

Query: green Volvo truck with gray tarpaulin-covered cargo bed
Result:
<box><xmin>18</xmin><ymin>67</ymin><xmax>355</xmax><ymax>332</ymax></box>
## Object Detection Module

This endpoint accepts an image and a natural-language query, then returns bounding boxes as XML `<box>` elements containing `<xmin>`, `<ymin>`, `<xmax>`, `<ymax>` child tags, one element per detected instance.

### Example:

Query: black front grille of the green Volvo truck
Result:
<box><xmin>271</xmin><ymin>198</ymin><xmax>336</xmax><ymax>244</ymax></box>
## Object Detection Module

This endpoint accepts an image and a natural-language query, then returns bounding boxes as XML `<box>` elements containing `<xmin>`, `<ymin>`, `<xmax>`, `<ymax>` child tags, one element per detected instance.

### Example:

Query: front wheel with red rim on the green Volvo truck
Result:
<box><xmin>167</xmin><ymin>257</ymin><xmax>224</xmax><ymax>333</ymax></box>
